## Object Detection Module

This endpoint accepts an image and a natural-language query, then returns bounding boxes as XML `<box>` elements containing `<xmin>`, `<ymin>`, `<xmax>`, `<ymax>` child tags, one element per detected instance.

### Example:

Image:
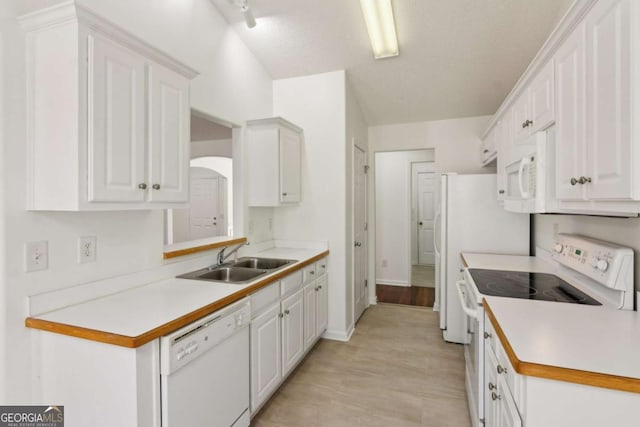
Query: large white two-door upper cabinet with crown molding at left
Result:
<box><xmin>20</xmin><ymin>2</ymin><xmax>196</xmax><ymax>211</ymax></box>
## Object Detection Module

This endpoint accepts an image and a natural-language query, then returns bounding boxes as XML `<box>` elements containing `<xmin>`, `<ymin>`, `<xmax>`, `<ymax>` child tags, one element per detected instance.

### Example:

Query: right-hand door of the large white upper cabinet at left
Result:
<box><xmin>149</xmin><ymin>65</ymin><xmax>191</xmax><ymax>202</ymax></box>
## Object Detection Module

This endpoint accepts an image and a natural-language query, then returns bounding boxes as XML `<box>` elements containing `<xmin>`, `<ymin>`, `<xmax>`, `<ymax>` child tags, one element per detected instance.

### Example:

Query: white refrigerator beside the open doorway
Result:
<box><xmin>434</xmin><ymin>174</ymin><xmax>530</xmax><ymax>344</ymax></box>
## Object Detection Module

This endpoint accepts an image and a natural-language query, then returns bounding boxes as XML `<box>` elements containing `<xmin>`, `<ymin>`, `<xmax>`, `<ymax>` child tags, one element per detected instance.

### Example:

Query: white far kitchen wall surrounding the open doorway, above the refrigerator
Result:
<box><xmin>368</xmin><ymin>116</ymin><xmax>495</xmax><ymax>302</ymax></box>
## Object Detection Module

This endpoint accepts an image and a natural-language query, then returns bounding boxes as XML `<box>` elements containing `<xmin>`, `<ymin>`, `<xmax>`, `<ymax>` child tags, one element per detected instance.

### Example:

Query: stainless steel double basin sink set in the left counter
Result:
<box><xmin>177</xmin><ymin>257</ymin><xmax>297</xmax><ymax>285</ymax></box>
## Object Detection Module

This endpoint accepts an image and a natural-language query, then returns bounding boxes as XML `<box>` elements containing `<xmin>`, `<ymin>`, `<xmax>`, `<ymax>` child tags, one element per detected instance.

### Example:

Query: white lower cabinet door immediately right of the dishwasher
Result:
<box><xmin>251</xmin><ymin>303</ymin><xmax>282</xmax><ymax>412</ymax></box>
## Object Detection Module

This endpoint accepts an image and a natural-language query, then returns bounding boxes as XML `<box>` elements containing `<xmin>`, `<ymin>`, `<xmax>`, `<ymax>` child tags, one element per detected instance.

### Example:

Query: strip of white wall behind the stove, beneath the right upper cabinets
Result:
<box><xmin>533</xmin><ymin>215</ymin><xmax>640</xmax><ymax>291</ymax></box>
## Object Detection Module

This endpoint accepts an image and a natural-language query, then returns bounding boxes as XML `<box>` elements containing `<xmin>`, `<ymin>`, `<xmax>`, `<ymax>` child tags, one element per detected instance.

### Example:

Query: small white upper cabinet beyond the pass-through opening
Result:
<box><xmin>245</xmin><ymin>117</ymin><xmax>302</xmax><ymax>206</ymax></box>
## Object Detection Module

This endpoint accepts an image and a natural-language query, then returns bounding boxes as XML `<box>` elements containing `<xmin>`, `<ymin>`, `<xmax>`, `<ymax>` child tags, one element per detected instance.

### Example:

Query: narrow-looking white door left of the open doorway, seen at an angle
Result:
<box><xmin>353</xmin><ymin>147</ymin><xmax>368</xmax><ymax>322</ymax></box>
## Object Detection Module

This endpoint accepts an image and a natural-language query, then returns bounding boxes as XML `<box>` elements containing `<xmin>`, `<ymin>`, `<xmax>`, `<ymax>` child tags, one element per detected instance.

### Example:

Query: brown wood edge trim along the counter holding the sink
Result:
<box><xmin>24</xmin><ymin>250</ymin><xmax>329</xmax><ymax>348</ymax></box>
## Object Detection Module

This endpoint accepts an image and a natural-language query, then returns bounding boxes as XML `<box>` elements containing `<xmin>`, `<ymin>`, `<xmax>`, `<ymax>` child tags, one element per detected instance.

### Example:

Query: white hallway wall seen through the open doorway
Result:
<box><xmin>374</xmin><ymin>149</ymin><xmax>434</xmax><ymax>286</ymax></box>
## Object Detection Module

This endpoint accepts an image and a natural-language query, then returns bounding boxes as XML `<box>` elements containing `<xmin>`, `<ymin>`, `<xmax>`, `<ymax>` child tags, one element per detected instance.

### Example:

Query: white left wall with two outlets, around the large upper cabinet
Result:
<box><xmin>0</xmin><ymin>0</ymin><xmax>272</xmax><ymax>403</ymax></box>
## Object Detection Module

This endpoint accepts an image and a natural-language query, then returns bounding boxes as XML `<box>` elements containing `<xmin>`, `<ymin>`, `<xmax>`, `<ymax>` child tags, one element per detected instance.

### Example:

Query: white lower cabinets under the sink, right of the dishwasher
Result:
<box><xmin>250</xmin><ymin>260</ymin><xmax>328</xmax><ymax>414</ymax></box>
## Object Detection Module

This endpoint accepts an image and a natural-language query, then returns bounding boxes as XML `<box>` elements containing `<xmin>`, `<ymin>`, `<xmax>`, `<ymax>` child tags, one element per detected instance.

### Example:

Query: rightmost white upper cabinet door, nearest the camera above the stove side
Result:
<box><xmin>585</xmin><ymin>0</ymin><xmax>632</xmax><ymax>199</ymax></box>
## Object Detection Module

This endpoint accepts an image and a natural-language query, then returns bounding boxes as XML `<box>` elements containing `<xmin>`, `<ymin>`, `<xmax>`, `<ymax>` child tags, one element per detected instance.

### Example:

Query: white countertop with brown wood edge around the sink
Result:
<box><xmin>25</xmin><ymin>247</ymin><xmax>329</xmax><ymax>347</ymax></box>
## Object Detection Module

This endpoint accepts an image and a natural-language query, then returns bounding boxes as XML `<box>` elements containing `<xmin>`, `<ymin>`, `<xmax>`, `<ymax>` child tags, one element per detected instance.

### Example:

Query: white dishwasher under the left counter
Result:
<box><xmin>160</xmin><ymin>298</ymin><xmax>251</xmax><ymax>427</ymax></box>
